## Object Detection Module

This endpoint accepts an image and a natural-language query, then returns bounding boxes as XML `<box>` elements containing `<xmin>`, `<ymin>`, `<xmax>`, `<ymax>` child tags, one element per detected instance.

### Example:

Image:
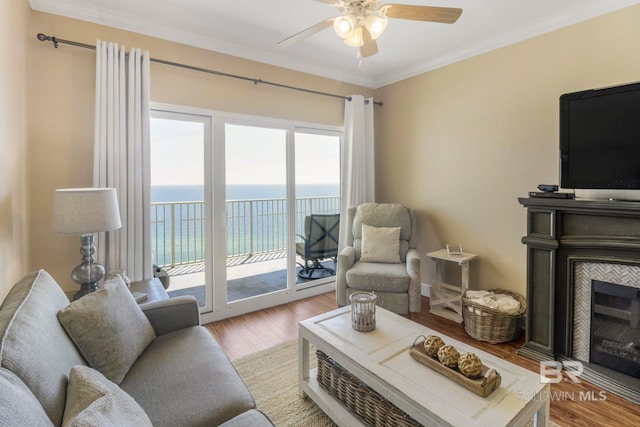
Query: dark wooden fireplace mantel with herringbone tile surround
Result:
<box><xmin>519</xmin><ymin>198</ymin><xmax>640</xmax><ymax>404</ymax></box>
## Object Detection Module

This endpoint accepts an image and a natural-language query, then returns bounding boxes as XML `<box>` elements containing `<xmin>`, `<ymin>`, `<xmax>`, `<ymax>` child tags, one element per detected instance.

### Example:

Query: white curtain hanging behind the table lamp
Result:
<box><xmin>93</xmin><ymin>40</ymin><xmax>153</xmax><ymax>281</ymax></box>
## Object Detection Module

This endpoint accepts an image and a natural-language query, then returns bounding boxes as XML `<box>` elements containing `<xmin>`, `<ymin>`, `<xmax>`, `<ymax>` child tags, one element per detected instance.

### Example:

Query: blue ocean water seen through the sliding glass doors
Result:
<box><xmin>151</xmin><ymin>184</ymin><xmax>340</xmax><ymax>265</ymax></box>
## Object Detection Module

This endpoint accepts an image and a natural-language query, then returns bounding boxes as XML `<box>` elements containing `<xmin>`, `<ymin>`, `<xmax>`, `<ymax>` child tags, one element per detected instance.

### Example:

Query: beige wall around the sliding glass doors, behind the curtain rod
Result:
<box><xmin>30</xmin><ymin>12</ymin><xmax>373</xmax><ymax>290</ymax></box>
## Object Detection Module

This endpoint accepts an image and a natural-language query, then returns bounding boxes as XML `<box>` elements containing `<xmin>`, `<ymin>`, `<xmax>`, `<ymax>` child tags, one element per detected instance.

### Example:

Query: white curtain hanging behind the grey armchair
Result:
<box><xmin>338</xmin><ymin>95</ymin><xmax>375</xmax><ymax>250</ymax></box>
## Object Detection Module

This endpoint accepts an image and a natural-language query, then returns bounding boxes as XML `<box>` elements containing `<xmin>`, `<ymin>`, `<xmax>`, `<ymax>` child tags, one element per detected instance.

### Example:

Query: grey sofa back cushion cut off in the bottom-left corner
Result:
<box><xmin>0</xmin><ymin>368</ymin><xmax>53</xmax><ymax>427</ymax></box>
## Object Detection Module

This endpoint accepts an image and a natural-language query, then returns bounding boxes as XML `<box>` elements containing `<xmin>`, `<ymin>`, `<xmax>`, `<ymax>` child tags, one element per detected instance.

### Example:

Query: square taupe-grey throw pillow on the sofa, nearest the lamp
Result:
<box><xmin>58</xmin><ymin>277</ymin><xmax>156</xmax><ymax>384</ymax></box>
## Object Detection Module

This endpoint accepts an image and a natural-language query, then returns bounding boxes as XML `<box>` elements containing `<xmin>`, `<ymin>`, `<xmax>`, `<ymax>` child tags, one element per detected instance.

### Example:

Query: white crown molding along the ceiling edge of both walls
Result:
<box><xmin>30</xmin><ymin>0</ymin><xmax>640</xmax><ymax>89</ymax></box>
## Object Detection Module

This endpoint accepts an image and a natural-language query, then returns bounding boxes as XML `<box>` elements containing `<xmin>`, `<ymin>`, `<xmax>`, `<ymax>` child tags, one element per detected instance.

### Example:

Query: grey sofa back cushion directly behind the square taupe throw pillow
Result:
<box><xmin>0</xmin><ymin>270</ymin><xmax>86</xmax><ymax>425</ymax></box>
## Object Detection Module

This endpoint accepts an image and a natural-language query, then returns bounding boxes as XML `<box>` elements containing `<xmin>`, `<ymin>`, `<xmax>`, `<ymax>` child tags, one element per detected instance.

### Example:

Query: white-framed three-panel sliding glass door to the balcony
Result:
<box><xmin>151</xmin><ymin>104</ymin><xmax>342</xmax><ymax>322</ymax></box>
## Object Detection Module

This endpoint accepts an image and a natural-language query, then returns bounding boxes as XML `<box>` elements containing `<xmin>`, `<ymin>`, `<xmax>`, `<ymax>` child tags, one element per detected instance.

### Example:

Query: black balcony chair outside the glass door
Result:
<box><xmin>296</xmin><ymin>214</ymin><xmax>340</xmax><ymax>280</ymax></box>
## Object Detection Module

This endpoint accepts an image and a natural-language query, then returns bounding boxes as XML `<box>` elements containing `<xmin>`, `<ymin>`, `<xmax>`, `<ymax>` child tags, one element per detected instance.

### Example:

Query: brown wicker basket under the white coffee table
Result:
<box><xmin>316</xmin><ymin>350</ymin><xmax>420</xmax><ymax>427</ymax></box>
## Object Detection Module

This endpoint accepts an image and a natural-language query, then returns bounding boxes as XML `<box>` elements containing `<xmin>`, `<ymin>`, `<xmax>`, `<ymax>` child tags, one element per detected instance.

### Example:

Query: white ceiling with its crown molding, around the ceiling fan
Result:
<box><xmin>30</xmin><ymin>0</ymin><xmax>640</xmax><ymax>88</ymax></box>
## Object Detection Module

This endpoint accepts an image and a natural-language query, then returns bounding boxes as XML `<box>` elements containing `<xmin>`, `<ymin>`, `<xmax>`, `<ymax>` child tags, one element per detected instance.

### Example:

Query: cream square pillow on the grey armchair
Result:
<box><xmin>360</xmin><ymin>224</ymin><xmax>400</xmax><ymax>263</ymax></box>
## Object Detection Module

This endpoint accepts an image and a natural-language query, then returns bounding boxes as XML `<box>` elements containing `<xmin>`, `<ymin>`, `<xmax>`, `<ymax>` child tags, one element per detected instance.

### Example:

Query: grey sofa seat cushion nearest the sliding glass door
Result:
<box><xmin>120</xmin><ymin>326</ymin><xmax>255</xmax><ymax>427</ymax></box>
